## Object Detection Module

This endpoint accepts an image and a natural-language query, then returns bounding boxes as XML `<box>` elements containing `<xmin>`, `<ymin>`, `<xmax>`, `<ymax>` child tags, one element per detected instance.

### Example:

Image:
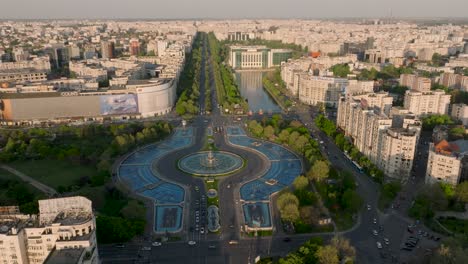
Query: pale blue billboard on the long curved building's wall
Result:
<box><xmin>99</xmin><ymin>94</ymin><xmax>138</xmax><ymax>115</ymax></box>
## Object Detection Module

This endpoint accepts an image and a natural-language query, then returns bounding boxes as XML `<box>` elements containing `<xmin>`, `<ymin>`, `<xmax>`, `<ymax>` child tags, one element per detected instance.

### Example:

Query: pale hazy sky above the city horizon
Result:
<box><xmin>0</xmin><ymin>0</ymin><xmax>468</xmax><ymax>19</ymax></box>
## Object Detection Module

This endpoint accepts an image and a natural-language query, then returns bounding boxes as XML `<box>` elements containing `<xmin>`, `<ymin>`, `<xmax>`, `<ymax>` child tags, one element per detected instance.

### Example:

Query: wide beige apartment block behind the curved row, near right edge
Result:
<box><xmin>404</xmin><ymin>90</ymin><xmax>450</xmax><ymax>116</ymax></box>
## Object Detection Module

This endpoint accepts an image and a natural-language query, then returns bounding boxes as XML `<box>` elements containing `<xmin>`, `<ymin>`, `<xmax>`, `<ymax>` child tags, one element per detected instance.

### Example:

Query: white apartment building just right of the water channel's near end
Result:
<box><xmin>293</xmin><ymin>73</ymin><xmax>348</xmax><ymax>107</ymax></box>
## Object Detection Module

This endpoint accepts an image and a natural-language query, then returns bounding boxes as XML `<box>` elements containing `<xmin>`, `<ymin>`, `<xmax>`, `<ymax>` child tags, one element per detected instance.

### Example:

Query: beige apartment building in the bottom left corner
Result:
<box><xmin>0</xmin><ymin>196</ymin><xmax>99</xmax><ymax>264</ymax></box>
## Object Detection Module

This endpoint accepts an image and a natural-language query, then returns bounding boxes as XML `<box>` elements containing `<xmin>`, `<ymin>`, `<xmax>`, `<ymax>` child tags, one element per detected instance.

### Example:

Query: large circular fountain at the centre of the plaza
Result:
<box><xmin>178</xmin><ymin>151</ymin><xmax>244</xmax><ymax>176</ymax></box>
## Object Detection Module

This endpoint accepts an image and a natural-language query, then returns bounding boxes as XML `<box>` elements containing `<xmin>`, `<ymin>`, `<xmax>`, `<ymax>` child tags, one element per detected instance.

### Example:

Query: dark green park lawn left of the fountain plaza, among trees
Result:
<box><xmin>9</xmin><ymin>159</ymin><xmax>97</xmax><ymax>189</ymax></box>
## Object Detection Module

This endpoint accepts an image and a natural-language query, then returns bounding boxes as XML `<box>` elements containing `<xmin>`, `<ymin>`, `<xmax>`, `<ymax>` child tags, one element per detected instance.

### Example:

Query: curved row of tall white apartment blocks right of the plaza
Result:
<box><xmin>337</xmin><ymin>94</ymin><xmax>421</xmax><ymax>181</ymax></box>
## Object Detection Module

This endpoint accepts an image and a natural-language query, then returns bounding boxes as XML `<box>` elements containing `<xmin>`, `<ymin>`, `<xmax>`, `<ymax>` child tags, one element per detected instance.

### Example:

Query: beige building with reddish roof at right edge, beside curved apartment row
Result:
<box><xmin>426</xmin><ymin>140</ymin><xmax>468</xmax><ymax>185</ymax></box>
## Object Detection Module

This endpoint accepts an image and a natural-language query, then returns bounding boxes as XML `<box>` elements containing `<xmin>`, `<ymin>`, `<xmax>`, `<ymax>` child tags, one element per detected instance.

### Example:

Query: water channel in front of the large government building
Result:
<box><xmin>236</xmin><ymin>71</ymin><xmax>281</xmax><ymax>113</ymax></box>
